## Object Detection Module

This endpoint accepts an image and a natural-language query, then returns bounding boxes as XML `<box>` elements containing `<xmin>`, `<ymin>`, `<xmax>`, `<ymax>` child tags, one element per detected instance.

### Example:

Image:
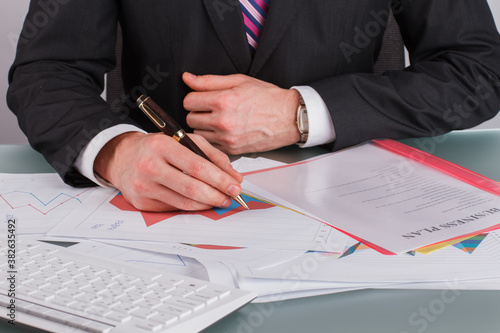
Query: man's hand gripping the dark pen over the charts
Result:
<box><xmin>94</xmin><ymin>132</ymin><xmax>243</xmax><ymax>211</ymax></box>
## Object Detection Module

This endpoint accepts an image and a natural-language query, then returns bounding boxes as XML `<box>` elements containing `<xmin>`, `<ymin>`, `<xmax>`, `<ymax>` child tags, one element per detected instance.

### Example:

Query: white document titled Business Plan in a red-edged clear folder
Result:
<box><xmin>245</xmin><ymin>143</ymin><xmax>500</xmax><ymax>253</ymax></box>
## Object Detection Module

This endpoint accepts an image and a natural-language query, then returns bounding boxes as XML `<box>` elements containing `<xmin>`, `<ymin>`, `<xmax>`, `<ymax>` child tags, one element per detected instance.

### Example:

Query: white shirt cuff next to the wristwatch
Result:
<box><xmin>291</xmin><ymin>86</ymin><xmax>337</xmax><ymax>148</ymax></box>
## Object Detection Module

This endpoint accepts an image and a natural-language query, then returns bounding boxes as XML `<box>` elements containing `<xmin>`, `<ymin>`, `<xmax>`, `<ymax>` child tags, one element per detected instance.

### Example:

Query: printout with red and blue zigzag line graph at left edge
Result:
<box><xmin>0</xmin><ymin>174</ymin><xmax>104</xmax><ymax>234</ymax></box>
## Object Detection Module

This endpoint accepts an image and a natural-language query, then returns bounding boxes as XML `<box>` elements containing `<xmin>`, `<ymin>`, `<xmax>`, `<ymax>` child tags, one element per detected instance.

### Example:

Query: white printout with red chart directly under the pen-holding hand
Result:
<box><xmin>48</xmin><ymin>188</ymin><xmax>347</xmax><ymax>252</ymax></box>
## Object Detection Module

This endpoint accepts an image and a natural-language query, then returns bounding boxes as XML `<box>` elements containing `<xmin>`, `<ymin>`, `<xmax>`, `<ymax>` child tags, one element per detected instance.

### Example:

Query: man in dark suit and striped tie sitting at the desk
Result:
<box><xmin>8</xmin><ymin>0</ymin><xmax>500</xmax><ymax>210</ymax></box>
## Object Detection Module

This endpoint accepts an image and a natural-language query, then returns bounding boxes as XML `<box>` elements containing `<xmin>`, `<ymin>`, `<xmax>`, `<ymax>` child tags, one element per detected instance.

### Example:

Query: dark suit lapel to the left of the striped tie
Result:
<box><xmin>203</xmin><ymin>0</ymin><xmax>252</xmax><ymax>73</ymax></box>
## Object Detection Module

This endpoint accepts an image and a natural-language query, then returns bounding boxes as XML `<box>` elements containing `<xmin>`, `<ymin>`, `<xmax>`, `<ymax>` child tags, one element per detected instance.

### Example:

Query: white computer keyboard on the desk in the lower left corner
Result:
<box><xmin>0</xmin><ymin>239</ymin><xmax>256</xmax><ymax>333</ymax></box>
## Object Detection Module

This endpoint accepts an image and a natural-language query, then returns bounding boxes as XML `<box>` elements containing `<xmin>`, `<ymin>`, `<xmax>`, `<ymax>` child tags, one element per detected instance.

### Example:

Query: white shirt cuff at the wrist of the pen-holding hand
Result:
<box><xmin>75</xmin><ymin>124</ymin><xmax>146</xmax><ymax>187</ymax></box>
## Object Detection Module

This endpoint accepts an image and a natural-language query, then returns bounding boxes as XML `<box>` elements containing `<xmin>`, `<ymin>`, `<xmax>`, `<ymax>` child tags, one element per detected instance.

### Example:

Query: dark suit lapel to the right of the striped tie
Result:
<box><xmin>249</xmin><ymin>0</ymin><xmax>303</xmax><ymax>76</ymax></box>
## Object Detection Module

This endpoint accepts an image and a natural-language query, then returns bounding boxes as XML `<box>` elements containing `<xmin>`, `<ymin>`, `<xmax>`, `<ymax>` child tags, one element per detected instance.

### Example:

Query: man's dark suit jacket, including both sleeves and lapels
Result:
<box><xmin>8</xmin><ymin>0</ymin><xmax>500</xmax><ymax>185</ymax></box>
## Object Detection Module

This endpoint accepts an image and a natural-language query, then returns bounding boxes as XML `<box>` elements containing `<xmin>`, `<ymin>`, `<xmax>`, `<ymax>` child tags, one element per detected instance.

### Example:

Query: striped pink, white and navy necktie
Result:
<box><xmin>240</xmin><ymin>0</ymin><xmax>271</xmax><ymax>54</ymax></box>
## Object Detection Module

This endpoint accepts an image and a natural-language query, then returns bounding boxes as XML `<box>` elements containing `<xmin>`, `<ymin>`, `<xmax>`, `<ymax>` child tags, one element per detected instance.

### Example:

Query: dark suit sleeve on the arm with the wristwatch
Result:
<box><xmin>311</xmin><ymin>0</ymin><xmax>500</xmax><ymax>150</ymax></box>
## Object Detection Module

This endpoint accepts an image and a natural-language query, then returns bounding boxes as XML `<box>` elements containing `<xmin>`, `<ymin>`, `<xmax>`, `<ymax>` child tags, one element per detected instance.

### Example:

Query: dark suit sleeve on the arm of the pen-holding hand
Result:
<box><xmin>7</xmin><ymin>0</ymin><xmax>128</xmax><ymax>186</ymax></box>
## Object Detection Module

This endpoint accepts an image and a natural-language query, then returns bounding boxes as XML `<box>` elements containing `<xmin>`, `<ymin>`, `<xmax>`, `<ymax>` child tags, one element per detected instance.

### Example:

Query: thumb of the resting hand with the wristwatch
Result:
<box><xmin>182</xmin><ymin>72</ymin><xmax>250</xmax><ymax>91</ymax></box>
